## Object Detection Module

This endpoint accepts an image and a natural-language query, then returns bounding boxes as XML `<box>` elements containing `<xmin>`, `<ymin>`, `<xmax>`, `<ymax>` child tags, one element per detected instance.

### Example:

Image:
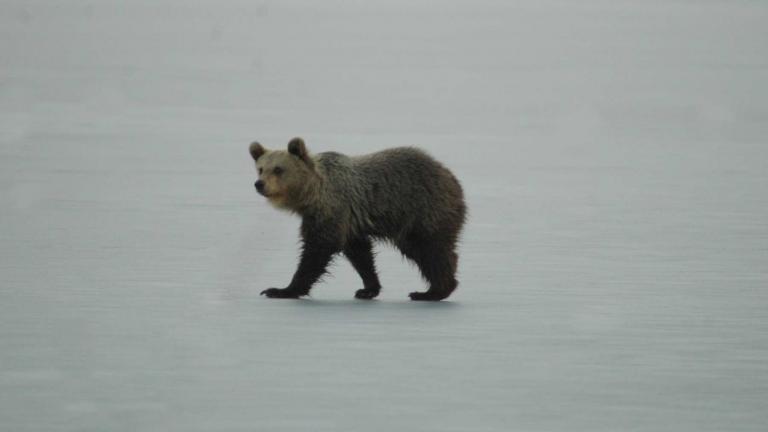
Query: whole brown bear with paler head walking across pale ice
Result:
<box><xmin>250</xmin><ymin>138</ymin><xmax>466</xmax><ymax>301</ymax></box>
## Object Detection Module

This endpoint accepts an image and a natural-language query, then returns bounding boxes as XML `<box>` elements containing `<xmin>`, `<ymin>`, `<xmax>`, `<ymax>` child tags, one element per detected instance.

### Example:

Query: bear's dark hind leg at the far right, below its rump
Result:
<box><xmin>398</xmin><ymin>238</ymin><xmax>459</xmax><ymax>301</ymax></box>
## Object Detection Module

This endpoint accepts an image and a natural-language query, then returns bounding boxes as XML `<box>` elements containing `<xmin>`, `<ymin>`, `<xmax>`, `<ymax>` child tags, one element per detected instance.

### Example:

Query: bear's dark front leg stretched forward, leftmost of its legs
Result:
<box><xmin>261</xmin><ymin>241</ymin><xmax>338</xmax><ymax>298</ymax></box>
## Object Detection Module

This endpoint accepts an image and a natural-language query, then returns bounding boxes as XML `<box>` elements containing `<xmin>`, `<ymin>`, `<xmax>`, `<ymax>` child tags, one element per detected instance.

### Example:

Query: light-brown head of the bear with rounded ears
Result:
<box><xmin>249</xmin><ymin>138</ymin><xmax>316</xmax><ymax>211</ymax></box>
